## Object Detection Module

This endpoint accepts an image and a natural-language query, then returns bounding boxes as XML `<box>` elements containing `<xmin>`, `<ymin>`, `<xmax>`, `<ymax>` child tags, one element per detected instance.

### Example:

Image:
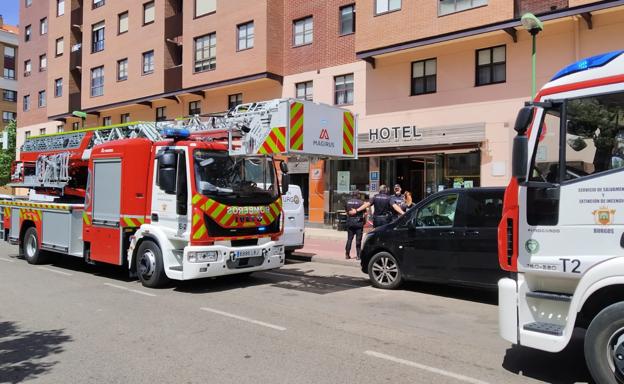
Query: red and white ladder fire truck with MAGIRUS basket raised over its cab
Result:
<box><xmin>0</xmin><ymin>99</ymin><xmax>357</xmax><ymax>287</ymax></box>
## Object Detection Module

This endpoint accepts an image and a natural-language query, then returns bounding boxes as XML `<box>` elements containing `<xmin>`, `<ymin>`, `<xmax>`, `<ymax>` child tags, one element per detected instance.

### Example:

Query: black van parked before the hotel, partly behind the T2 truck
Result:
<box><xmin>361</xmin><ymin>188</ymin><xmax>506</xmax><ymax>289</ymax></box>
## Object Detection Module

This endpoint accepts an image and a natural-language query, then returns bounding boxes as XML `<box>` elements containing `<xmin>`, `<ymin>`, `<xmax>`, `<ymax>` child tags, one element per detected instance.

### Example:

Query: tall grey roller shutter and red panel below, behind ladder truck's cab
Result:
<box><xmin>91</xmin><ymin>159</ymin><xmax>122</xmax><ymax>265</ymax></box>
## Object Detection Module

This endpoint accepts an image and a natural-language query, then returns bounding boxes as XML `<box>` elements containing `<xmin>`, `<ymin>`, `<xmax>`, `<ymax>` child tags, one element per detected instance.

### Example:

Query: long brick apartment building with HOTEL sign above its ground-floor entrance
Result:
<box><xmin>18</xmin><ymin>0</ymin><xmax>624</xmax><ymax>223</ymax></box>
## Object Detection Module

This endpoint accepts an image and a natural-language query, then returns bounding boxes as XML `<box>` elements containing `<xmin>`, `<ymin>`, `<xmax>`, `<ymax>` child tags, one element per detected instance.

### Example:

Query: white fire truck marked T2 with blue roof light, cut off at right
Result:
<box><xmin>498</xmin><ymin>51</ymin><xmax>624</xmax><ymax>384</ymax></box>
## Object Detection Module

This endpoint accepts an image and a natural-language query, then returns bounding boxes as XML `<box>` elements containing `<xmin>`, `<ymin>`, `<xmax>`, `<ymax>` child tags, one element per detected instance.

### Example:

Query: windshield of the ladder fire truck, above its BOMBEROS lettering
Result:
<box><xmin>193</xmin><ymin>149</ymin><xmax>278</xmax><ymax>204</ymax></box>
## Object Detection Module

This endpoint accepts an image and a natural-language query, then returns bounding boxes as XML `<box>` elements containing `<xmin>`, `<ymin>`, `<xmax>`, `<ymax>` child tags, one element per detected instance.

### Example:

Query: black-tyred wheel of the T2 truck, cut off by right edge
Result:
<box><xmin>585</xmin><ymin>302</ymin><xmax>624</xmax><ymax>384</ymax></box>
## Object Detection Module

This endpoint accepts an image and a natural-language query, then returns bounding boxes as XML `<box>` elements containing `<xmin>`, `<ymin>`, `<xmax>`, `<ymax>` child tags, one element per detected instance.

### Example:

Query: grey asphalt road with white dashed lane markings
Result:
<box><xmin>0</xmin><ymin>243</ymin><xmax>589</xmax><ymax>384</ymax></box>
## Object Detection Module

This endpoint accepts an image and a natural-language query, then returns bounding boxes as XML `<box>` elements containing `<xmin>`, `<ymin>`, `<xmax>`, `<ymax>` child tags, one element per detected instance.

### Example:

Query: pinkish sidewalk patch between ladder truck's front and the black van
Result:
<box><xmin>290</xmin><ymin>227</ymin><xmax>366</xmax><ymax>268</ymax></box>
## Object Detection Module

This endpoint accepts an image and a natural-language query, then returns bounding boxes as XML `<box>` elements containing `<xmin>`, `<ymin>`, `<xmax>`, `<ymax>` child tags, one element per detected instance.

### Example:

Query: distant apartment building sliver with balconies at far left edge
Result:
<box><xmin>0</xmin><ymin>15</ymin><xmax>18</xmax><ymax>130</ymax></box>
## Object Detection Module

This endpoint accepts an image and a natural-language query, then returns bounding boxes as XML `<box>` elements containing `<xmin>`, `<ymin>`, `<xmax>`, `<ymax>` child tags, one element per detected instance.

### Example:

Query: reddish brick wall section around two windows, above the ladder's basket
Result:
<box><xmin>283</xmin><ymin>0</ymin><xmax>357</xmax><ymax>75</ymax></box>
